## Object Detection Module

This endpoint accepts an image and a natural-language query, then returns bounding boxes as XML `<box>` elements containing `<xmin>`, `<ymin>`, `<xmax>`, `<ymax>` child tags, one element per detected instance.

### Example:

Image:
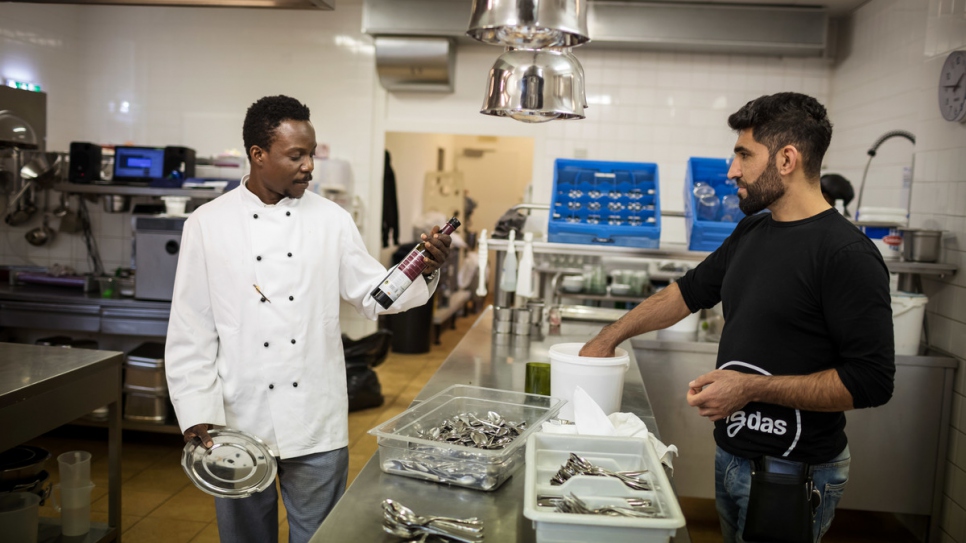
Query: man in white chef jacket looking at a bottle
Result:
<box><xmin>165</xmin><ymin>96</ymin><xmax>450</xmax><ymax>543</ymax></box>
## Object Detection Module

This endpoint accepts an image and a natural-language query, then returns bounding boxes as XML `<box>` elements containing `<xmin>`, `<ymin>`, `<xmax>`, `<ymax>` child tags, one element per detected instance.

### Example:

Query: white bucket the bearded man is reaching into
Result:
<box><xmin>550</xmin><ymin>343</ymin><xmax>630</xmax><ymax>420</ymax></box>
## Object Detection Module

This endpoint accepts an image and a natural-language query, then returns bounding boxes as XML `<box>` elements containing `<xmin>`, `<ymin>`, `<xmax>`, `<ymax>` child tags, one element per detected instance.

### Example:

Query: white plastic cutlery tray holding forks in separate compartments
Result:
<box><xmin>523</xmin><ymin>433</ymin><xmax>685</xmax><ymax>543</ymax></box>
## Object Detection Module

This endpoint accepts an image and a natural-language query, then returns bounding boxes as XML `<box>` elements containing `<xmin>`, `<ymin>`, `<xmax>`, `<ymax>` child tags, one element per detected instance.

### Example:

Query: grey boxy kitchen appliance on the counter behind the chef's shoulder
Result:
<box><xmin>134</xmin><ymin>217</ymin><xmax>185</xmax><ymax>301</ymax></box>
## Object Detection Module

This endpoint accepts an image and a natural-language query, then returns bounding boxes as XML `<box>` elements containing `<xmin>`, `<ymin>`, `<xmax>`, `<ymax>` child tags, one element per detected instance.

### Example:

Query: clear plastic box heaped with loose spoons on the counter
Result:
<box><xmin>369</xmin><ymin>385</ymin><xmax>565</xmax><ymax>490</ymax></box>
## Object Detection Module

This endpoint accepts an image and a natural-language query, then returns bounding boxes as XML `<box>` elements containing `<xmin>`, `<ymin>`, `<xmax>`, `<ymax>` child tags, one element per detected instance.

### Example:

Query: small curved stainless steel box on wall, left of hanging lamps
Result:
<box><xmin>374</xmin><ymin>36</ymin><xmax>456</xmax><ymax>92</ymax></box>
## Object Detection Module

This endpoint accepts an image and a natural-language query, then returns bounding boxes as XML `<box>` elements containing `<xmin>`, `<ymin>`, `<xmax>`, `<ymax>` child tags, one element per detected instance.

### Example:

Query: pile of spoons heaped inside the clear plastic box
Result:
<box><xmin>417</xmin><ymin>411</ymin><xmax>527</xmax><ymax>449</ymax></box>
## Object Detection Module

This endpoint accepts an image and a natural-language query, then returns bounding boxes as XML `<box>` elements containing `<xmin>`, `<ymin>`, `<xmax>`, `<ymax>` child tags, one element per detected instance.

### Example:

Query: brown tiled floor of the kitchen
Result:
<box><xmin>31</xmin><ymin>315</ymin><xmax>916</xmax><ymax>543</ymax></box>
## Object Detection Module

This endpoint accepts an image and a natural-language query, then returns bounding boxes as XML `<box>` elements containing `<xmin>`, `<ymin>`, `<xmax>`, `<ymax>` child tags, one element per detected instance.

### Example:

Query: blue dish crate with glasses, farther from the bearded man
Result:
<box><xmin>547</xmin><ymin>158</ymin><xmax>661</xmax><ymax>249</ymax></box>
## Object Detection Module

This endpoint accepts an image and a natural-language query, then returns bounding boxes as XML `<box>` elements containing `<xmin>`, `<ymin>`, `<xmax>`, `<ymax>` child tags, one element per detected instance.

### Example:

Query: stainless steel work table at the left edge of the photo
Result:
<box><xmin>0</xmin><ymin>343</ymin><xmax>124</xmax><ymax>542</ymax></box>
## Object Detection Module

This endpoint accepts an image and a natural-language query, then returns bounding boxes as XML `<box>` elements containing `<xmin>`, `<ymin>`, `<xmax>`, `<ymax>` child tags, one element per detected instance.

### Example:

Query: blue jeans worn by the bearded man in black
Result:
<box><xmin>714</xmin><ymin>445</ymin><xmax>851</xmax><ymax>543</ymax></box>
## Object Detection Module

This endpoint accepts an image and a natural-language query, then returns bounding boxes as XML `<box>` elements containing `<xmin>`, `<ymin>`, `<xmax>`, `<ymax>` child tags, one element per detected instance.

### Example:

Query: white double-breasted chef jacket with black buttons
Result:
<box><xmin>165</xmin><ymin>178</ymin><xmax>436</xmax><ymax>459</ymax></box>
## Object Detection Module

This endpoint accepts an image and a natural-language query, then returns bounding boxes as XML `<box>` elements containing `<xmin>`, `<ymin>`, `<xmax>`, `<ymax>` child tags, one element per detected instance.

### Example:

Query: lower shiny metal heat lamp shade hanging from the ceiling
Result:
<box><xmin>480</xmin><ymin>49</ymin><xmax>586</xmax><ymax>123</ymax></box>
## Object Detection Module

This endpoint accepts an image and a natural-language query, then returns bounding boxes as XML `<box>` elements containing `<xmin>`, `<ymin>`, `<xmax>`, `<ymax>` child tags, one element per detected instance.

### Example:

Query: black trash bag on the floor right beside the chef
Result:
<box><xmin>342</xmin><ymin>330</ymin><xmax>392</xmax><ymax>412</ymax></box>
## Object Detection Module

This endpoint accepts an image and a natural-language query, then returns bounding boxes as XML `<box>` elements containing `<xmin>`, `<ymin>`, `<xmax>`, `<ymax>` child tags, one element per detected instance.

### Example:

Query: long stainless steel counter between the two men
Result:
<box><xmin>311</xmin><ymin>308</ymin><xmax>690</xmax><ymax>543</ymax></box>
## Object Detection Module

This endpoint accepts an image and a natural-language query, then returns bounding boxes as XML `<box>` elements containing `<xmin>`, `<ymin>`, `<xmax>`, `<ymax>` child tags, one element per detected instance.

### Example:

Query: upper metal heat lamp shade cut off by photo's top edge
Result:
<box><xmin>466</xmin><ymin>0</ymin><xmax>590</xmax><ymax>49</ymax></box>
